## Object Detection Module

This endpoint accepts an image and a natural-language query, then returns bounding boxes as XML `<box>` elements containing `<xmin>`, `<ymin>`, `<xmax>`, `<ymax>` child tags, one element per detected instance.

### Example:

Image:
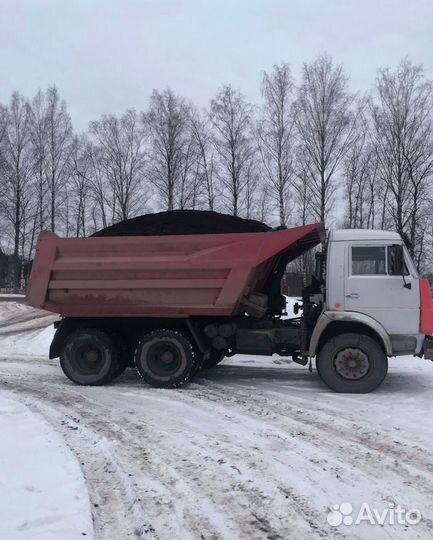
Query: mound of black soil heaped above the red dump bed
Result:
<box><xmin>92</xmin><ymin>210</ymin><xmax>270</xmax><ymax>236</ymax></box>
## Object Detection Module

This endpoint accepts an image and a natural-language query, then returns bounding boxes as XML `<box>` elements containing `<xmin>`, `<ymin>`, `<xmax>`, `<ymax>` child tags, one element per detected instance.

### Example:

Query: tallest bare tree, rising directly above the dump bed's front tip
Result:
<box><xmin>296</xmin><ymin>55</ymin><xmax>355</xmax><ymax>222</ymax></box>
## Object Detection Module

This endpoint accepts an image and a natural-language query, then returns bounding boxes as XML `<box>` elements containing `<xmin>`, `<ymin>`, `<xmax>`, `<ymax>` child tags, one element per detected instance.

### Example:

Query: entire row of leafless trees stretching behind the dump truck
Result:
<box><xmin>0</xmin><ymin>55</ymin><xmax>433</xmax><ymax>290</ymax></box>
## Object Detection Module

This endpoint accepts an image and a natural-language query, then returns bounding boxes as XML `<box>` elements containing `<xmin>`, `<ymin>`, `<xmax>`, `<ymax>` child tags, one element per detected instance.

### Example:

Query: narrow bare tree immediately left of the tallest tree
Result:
<box><xmin>257</xmin><ymin>64</ymin><xmax>294</xmax><ymax>225</ymax></box>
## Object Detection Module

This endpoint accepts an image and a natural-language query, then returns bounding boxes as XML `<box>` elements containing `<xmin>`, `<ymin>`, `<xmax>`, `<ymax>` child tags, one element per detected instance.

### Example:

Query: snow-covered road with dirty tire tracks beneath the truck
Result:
<box><xmin>0</xmin><ymin>302</ymin><xmax>433</xmax><ymax>540</ymax></box>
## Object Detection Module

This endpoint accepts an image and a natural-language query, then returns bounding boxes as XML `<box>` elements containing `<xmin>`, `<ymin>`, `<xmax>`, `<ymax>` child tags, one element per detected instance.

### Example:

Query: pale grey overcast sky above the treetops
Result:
<box><xmin>0</xmin><ymin>0</ymin><xmax>433</xmax><ymax>130</ymax></box>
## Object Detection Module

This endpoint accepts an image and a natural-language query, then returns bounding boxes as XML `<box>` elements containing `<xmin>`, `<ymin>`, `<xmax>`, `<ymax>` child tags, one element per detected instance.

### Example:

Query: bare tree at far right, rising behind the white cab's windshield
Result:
<box><xmin>371</xmin><ymin>60</ymin><xmax>433</xmax><ymax>264</ymax></box>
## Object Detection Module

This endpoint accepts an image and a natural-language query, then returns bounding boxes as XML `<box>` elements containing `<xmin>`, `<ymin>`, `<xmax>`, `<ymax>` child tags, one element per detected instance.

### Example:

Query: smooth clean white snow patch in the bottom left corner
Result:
<box><xmin>0</xmin><ymin>391</ymin><xmax>93</xmax><ymax>540</ymax></box>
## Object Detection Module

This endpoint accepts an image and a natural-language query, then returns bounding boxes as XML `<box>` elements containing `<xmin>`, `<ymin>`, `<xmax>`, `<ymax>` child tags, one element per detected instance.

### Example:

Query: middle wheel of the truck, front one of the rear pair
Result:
<box><xmin>135</xmin><ymin>329</ymin><xmax>195</xmax><ymax>388</ymax></box>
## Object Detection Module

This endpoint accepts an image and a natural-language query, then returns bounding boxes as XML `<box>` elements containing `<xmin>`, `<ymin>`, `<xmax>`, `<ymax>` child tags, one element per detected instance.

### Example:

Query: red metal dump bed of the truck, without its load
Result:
<box><xmin>27</xmin><ymin>224</ymin><xmax>323</xmax><ymax>317</ymax></box>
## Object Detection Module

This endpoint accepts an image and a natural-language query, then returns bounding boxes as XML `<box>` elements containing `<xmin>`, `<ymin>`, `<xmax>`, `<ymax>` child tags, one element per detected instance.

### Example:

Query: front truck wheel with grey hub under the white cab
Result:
<box><xmin>316</xmin><ymin>333</ymin><xmax>388</xmax><ymax>394</ymax></box>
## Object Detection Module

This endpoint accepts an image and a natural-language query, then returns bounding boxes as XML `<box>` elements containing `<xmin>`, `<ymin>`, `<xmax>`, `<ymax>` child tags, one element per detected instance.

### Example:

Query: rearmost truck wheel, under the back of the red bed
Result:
<box><xmin>60</xmin><ymin>328</ymin><xmax>121</xmax><ymax>386</ymax></box>
